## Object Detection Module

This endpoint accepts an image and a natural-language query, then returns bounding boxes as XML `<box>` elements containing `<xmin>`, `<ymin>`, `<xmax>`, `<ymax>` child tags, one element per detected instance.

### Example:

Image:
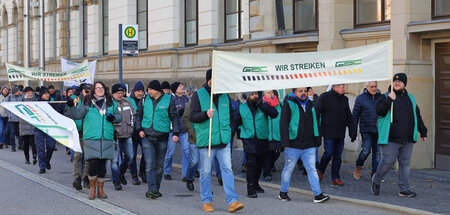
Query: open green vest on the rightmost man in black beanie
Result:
<box><xmin>377</xmin><ymin>92</ymin><xmax>417</xmax><ymax>144</ymax></box>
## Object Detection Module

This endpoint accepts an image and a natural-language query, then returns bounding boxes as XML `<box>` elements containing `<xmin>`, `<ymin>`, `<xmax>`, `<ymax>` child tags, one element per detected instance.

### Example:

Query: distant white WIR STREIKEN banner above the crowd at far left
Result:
<box><xmin>6</xmin><ymin>60</ymin><xmax>90</xmax><ymax>81</ymax></box>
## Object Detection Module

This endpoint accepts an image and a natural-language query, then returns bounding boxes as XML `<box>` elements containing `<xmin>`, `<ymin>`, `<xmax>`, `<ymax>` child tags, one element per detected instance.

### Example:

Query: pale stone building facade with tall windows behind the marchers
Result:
<box><xmin>0</xmin><ymin>0</ymin><xmax>450</xmax><ymax>168</ymax></box>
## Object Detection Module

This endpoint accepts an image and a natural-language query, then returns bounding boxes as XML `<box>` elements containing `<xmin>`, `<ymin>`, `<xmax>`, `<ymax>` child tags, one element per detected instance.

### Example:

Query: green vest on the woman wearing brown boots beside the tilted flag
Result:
<box><xmin>83</xmin><ymin>101</ymin><xmax>117</xmax><ymax>140</ymax></box>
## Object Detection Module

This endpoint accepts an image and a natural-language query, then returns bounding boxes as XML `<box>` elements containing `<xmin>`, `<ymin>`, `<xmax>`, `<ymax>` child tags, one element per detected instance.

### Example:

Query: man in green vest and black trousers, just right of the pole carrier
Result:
<box><xmin>233</xmin><ymin>92</ymin><xmax>278</xmax><ymax>198</ymax></box>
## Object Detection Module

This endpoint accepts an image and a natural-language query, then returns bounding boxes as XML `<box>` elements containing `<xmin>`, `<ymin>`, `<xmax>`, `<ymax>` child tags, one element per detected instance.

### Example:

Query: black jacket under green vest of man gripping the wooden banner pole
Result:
<box><xmin>190</xmin><ymin>84</ymin><xmax>234</xmax><ymax>148</ymax></box>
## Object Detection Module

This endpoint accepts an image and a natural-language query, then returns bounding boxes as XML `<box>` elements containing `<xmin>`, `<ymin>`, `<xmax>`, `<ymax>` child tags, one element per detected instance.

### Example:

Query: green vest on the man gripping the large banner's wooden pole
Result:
<box><xmin>194</xmin><ymin>88</ymin><xmax>231</xmax><ymax>147</ymax></box>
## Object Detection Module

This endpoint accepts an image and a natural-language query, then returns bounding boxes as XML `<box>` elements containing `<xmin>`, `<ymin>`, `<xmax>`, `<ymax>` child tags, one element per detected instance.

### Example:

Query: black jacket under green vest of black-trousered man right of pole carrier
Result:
<box><xmin>231</xmin><ymin>100</ymin><xmax>278</xmax><ymax>154</ymax></box>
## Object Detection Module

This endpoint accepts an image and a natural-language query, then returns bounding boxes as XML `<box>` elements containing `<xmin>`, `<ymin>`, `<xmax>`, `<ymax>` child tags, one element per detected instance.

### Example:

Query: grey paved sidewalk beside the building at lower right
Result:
<box><xmin>170</xmin><ymin>145</ymin><xmax>450</xmax><ymax>214</ymax></box>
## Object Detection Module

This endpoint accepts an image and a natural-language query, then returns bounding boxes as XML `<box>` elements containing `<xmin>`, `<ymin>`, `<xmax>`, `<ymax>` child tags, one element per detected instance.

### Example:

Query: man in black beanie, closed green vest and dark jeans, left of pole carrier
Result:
<box><xmin>135</xmin><ymin>80</ymin><xmax>180</xmax><ymax>199</ymax></box>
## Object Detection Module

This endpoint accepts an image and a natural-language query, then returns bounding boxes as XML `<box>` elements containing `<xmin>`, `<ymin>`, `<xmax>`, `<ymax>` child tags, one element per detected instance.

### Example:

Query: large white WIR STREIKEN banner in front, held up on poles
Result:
<box><xmin>212</xmin><ymin>41</ymin><xmax>393</xmax><ymax>93</ymax></box>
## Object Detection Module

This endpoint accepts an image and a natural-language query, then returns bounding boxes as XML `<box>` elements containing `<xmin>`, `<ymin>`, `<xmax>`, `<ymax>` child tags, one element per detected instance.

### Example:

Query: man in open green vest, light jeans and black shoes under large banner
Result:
<box><xmin>278</xmin><ymin>87</ymin><xmax>330</xmax><ymax>203</ymax></box>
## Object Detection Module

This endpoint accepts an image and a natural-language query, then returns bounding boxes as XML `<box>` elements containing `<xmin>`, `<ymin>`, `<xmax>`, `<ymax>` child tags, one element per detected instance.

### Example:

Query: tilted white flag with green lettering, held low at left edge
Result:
<box><xmin>1</xmin><ymin>102</ymin><xmax>82</xmax><ymax>152</ymax></box>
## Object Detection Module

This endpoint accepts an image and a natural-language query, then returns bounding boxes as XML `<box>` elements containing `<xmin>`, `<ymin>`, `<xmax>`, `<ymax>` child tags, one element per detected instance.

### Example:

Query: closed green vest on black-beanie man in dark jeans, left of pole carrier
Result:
<box><xmin>141</xmin><ymin>94</ymin><xmax>171</xmax><ymax>133</ymax></box>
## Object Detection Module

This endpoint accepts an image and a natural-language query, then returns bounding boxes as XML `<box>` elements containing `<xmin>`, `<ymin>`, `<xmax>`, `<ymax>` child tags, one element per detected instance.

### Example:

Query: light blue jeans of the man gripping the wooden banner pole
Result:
<box><xmin>199</xmin><ymin>144</ymin><xmax>238</xmax><ymax>205</ymax></box>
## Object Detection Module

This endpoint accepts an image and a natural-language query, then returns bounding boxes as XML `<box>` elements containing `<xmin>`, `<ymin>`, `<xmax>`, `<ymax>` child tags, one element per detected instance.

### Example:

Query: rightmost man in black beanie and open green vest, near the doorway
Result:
<box><xmin>371</xmin><ymin>73</ymin><xmax>427</xmax><ymax>198</ymax></box>
